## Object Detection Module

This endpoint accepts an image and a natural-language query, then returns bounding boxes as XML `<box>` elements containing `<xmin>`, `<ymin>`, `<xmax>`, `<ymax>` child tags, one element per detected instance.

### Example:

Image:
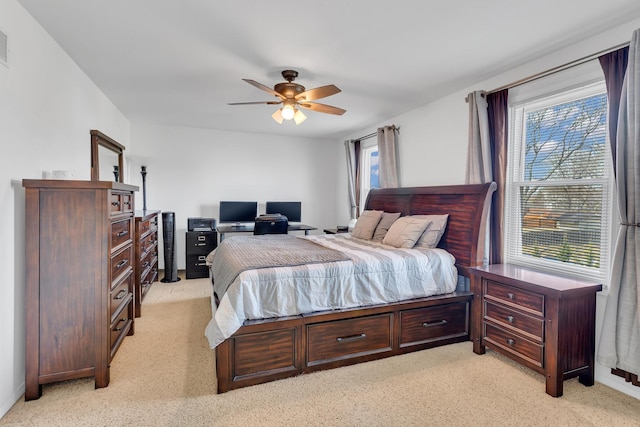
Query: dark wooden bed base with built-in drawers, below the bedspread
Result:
<box><xmin>216</xmin><ymin>292</ymin><xmax>473</xmax><ymax>393</ymax></box>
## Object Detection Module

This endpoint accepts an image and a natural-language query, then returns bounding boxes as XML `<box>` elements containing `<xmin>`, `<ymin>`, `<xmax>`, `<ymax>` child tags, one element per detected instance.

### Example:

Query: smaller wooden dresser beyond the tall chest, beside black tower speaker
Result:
<box><xmin>134</xmin><ymin>210</ymin><xmax>160</xmax><ymax>317</ymax></box>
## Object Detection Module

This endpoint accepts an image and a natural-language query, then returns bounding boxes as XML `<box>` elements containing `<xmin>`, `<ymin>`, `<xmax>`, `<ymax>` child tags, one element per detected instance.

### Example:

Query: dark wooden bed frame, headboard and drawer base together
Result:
<box><xmin>215</xmin><ymin>183</ymin><xmax>496</xmax><ymax>393</ymax></box>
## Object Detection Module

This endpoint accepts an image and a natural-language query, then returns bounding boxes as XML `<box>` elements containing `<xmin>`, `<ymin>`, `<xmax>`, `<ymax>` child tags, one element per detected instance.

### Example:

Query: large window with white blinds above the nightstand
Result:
<box><xmin>505</xmin><ymin>77</ymin><xmax>612</xmax><ymax>281</ymax></box>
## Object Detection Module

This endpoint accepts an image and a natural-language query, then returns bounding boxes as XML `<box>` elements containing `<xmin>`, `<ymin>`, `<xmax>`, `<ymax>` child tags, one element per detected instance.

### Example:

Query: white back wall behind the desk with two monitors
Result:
<box><xmin>129</xmin><ymin>123</ymin><xmax>336</xmax><ymax>269</ymax></box>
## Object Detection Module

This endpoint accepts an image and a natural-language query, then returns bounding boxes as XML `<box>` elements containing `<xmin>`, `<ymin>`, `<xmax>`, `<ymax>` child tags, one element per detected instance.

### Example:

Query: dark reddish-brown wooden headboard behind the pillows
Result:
<box><xmin>365</xmin><ymin>182</ymin><xmax>497</xmax><ymax>277</ymax></box>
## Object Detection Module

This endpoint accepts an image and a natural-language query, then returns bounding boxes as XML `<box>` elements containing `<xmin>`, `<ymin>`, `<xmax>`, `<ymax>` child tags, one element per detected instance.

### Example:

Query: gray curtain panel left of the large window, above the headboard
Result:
<box><xmin>465</xmin><ymin>91</ymin><xmax>493</xmax><ymax>184</ymax></box>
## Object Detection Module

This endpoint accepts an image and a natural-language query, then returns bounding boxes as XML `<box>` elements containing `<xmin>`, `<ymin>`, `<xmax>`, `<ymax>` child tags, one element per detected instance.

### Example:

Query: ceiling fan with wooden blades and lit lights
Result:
<box><xmin>229</xmin><ymin>70</ymin><xmax>347</xmax><ymax>125</ymax></box>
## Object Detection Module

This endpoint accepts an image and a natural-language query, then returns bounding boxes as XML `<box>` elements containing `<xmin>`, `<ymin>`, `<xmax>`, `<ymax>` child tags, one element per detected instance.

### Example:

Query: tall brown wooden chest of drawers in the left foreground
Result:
<box><xmin>22</xmin><ymin>180</ymin><xmax>138</xmax><ymax>400</ymax></box>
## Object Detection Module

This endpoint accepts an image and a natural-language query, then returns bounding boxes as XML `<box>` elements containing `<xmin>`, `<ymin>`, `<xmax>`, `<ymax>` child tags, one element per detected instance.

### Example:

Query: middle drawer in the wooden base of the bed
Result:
<box><xmin>307</xmin><ymin>313</ymin><xmax>392</xmax><ymax>366</ymax></box>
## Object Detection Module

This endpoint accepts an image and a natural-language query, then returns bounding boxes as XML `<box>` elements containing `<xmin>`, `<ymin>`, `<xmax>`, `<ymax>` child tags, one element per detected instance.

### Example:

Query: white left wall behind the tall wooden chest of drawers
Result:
<box><xmin>0</xmin><ymin>0</ymin><xmax>130</xmax><ymax>416</ymax></box>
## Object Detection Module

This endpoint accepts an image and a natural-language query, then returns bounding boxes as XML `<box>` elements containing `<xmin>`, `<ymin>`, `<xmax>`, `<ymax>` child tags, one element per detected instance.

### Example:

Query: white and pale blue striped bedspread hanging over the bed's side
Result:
<box><xmin>205</xmin><ymin>234</ymin><xmax>458</xmax><ymax>348</ymax></box>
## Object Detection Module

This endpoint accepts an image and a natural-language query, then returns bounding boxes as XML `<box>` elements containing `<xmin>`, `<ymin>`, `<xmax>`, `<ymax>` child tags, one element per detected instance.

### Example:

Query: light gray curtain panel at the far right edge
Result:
<box><xmin>598</xmin><ymin>30</ymin><xmax>640</xmax><ymax>375</ymax></box>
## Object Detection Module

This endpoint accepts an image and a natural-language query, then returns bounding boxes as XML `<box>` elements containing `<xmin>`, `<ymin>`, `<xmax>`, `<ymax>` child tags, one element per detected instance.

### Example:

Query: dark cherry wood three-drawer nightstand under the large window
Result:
<box><xmin>469</xmin><ymin>264</ymin><xmax>602</xmax><ymax>397</ymax></box>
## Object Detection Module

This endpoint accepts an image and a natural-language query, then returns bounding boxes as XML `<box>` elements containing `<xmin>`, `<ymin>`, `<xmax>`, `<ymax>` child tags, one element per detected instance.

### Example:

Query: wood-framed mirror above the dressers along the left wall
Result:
<box><xmin>91</xmin><ymin>129</ymin><xmax>124</xmax><ymax>182</ymax></box>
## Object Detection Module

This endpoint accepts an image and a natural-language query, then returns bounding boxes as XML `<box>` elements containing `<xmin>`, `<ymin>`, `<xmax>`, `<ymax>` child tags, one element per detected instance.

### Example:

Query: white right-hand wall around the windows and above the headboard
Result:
<box><xmin>336</xmin><ymin>17</ymin><xmax>640</xmax><ymax>399</ymax></box>
